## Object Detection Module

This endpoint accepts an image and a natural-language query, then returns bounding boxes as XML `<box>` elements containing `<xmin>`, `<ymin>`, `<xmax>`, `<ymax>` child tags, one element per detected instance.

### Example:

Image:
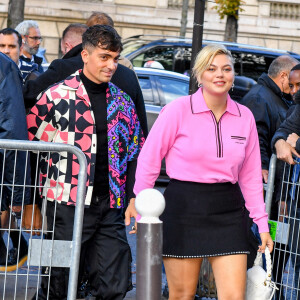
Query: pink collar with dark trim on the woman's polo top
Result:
<box><xmin>190</xmin><ymin>88</ymin><xmax>241</xmax><ymax>117</ymax></box>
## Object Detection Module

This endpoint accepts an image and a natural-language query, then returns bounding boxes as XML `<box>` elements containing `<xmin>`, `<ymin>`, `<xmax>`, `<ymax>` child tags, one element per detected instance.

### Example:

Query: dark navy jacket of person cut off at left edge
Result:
<box><xmin>0</xmin><ymin>53</ymin><xmax>30</xmax><ymax>205</ymax></box>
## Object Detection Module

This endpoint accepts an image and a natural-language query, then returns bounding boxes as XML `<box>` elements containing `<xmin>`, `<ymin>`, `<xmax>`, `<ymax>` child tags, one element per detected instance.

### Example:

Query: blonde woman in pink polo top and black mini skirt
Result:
<box><xmin>126</xmin><ymin>44</ymin><xmax>273</xmax><ymax>300</ymax></box>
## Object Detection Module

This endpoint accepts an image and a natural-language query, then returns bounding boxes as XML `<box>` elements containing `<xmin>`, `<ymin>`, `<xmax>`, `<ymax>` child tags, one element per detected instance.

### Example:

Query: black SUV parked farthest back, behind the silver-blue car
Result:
<box><xmin>122</xmin><ymin>35</ymin><xmax>300</xmax><ymax>80</ymax></box>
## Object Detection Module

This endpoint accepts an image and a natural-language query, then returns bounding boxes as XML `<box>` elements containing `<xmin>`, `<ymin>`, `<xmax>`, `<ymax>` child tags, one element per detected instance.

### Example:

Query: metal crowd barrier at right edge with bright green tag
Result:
<box><xmin>266</xmin><ymin>155</ymin><xmax>300</xmax><ymax>300</ymax></box>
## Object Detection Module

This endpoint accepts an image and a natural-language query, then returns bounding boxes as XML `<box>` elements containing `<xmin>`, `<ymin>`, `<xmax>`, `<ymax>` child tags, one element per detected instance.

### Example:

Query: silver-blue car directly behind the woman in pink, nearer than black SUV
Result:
<box><xmin>134</xmin><ymin>67</ymin><xmax>256</xmax><ymax>130</ymax></box>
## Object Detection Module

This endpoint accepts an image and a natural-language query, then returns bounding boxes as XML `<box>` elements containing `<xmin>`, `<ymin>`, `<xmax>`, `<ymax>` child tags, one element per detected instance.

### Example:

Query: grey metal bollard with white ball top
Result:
<box><xmin>135</xmin><ymin>189</ymin><xmax>165</xmax><ymax>300</ymax></box>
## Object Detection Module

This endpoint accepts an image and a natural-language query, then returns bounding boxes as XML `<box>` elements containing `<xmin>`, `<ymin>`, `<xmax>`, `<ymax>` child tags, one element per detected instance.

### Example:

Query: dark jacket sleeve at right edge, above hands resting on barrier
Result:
<box><xmin>272</xmin><ymin>104</ymin><xmax>300</xmax><ymax>153</ymax></box>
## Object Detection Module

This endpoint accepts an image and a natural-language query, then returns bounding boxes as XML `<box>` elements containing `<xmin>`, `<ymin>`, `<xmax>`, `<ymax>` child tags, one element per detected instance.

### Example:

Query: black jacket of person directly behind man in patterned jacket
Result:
<box><xmin>23</xmin><ymin>44</ymin><xmax>148</xmax><ymax>137</ymax></box>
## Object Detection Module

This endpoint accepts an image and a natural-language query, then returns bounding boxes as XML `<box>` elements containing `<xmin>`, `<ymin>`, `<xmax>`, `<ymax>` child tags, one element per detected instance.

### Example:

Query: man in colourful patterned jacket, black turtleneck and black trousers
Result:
<box><xmin>27</xmin><ymin>25</ymin><xmax>144</xmax><ymax>300</ymax></box>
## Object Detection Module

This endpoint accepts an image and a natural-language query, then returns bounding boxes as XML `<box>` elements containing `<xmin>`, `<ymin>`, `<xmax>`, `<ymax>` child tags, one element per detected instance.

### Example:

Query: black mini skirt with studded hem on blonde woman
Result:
<box><xmin>160</xmin><ymin>179</ymin><xmax>249</xmax><ymax>258</ymax></box>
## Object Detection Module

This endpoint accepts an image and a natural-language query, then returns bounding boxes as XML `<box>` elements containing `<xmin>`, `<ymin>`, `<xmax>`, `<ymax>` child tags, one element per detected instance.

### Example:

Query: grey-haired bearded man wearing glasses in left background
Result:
<box><xmin>16</xmin><ymin>20</ymin><xmax>43</xmax><ymax>79</ymax></box>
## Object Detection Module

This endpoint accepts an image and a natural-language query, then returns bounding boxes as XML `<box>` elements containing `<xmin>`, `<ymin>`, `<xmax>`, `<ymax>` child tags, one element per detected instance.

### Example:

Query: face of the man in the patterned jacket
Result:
<box><xmin>81</xmin><ymin>46</ymin><xmax>120</xmax><ymax>84</ymax></box>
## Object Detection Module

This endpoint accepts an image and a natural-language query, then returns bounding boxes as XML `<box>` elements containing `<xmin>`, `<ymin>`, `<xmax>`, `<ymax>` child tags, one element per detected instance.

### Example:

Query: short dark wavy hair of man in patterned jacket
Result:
<box><xmin>82</xmin><ymin>25</ymin><xmax>123</xmax><ymax>52</ymax></box>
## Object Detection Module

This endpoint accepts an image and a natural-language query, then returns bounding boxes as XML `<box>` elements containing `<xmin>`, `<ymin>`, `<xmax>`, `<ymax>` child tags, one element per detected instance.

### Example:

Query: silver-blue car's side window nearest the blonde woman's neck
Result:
<box><xmin>158</xmin><ymin>77</ymin><xmax>189</xmax><ymax>104</ymax></box>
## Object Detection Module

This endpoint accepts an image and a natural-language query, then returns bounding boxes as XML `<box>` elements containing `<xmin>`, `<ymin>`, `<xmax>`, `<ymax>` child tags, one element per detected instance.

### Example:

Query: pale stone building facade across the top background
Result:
<box><xmin>0</xmin><ymin>0</ymin><xmax>300</xmax><ymax>61</ymax></box>
